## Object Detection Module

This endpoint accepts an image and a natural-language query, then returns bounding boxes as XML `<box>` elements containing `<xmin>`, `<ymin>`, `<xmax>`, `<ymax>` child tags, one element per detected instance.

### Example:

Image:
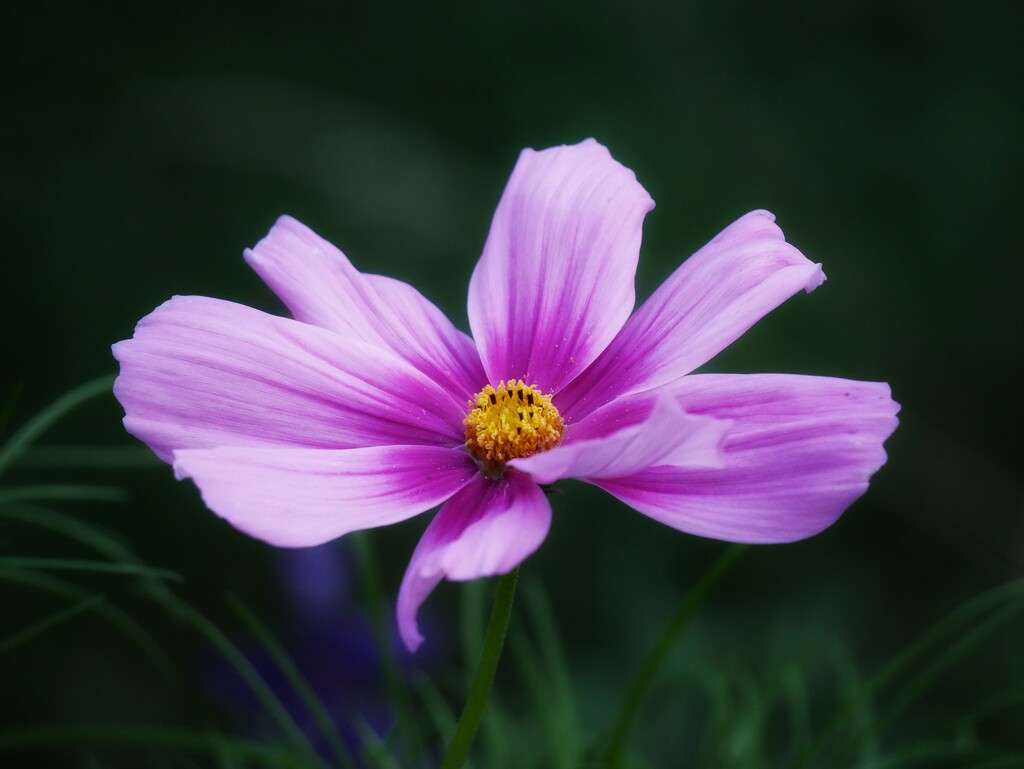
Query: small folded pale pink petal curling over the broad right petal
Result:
<box><xmin>509</xmin><ymin>395</ymin><xmax>731</xmax><ymax>484</ymax></box>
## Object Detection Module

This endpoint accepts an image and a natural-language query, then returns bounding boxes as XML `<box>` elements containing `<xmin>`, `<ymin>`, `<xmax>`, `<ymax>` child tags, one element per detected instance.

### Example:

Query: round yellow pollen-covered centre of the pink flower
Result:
<box><xmin>463</xmin><ymin>379</ymin><xmax>565</xmax><ymax>469</ymax></box>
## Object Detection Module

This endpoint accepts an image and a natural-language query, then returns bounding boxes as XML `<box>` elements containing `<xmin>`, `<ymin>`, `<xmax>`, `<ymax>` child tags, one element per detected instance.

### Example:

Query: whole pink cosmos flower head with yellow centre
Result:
<box><xmin>114</xmin><ymin>139</ymin><xmax>898</xmax><ymax>649</ymax></box>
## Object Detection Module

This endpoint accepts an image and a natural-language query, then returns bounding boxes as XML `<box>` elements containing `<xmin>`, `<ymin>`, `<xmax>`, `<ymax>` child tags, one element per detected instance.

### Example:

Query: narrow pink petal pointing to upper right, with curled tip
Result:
<box><xmin>560</xmin><ymin>211</ymin><xmax>824</xmax><ymax>416</ymax></box>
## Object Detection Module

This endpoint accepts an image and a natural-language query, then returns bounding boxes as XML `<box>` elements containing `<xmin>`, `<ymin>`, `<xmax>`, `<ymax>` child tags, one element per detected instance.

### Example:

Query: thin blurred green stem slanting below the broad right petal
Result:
<box><xmin>607</xmin><ymin>545</ymin><xmax>746</xmax><ymax>769</ymax></box>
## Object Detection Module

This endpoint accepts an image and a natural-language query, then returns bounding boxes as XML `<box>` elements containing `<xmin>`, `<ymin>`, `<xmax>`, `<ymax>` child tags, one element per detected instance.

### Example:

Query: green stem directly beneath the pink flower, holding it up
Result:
<box><xmin>441</xmin><ymin>566</ymin><xmax>519</xmax><ymax>769</ymax></box>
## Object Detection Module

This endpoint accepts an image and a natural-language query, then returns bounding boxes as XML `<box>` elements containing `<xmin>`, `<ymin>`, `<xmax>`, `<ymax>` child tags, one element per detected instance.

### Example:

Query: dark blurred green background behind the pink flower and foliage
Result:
<box><xmin>0</xmin><ymin>0</ymin><xmax>1024</xmax><ymax>766</ymax></box>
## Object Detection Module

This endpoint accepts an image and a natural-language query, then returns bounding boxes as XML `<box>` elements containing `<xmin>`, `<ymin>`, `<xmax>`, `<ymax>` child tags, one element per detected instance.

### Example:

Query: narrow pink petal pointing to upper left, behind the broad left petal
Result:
<box><xmin>246</xmin><ymin>216</ymin><xmax>484</xmax><ymax>400</ymax></box>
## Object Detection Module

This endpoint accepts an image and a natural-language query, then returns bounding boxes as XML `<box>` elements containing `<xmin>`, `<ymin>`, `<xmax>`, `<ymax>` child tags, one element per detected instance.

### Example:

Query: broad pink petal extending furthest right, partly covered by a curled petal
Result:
<box><xmin>595</xmin><ymin>374</ymin><xmax>899</xmax><ymax>543</ymax></box>
